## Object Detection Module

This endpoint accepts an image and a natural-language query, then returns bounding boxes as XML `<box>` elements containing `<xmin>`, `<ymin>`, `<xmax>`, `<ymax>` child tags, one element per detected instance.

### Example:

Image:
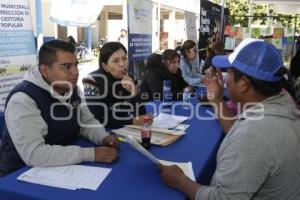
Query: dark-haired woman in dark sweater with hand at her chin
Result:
<box><xmin>83</xmin><ymin>42</ymin><xmax>146</xmax><ymax>128</ymax></box>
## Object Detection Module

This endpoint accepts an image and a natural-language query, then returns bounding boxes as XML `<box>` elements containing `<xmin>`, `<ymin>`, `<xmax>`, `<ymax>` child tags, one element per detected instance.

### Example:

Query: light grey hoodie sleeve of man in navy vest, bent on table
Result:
<box><xmin>5</xmin><ymin>92</ymin><xmax>95</xmax><ymax>166</ymax></box>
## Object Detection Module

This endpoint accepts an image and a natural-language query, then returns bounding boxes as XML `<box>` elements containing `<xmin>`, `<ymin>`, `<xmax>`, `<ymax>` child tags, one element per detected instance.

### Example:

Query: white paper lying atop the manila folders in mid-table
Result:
<box><xmin>152</xmin><ymin>113</ymin><xmax>188</xmax><ymax>129</ymax></box>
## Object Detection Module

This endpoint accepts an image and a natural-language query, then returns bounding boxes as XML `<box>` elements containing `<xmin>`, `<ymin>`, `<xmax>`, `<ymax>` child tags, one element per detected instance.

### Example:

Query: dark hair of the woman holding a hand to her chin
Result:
<box><xmin>99</xmin><ymin>42</ymin><xmax>127</xmax><ymax>67</ymax></box>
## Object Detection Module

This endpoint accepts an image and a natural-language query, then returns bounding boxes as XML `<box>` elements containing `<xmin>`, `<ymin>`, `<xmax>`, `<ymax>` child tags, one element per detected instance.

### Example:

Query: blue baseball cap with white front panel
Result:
<box><xmin>212</xmin><ymin>38</ymin><xmax>283</xmax><ymax>82</ymax></box>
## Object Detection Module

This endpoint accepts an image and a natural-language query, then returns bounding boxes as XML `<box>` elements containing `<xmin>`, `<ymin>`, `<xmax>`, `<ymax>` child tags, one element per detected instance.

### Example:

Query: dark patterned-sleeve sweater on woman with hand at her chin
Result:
<box><xmin>83</xmin><ymin>69</ymin><xmax>146</xmax><ymax>129</ymax></box>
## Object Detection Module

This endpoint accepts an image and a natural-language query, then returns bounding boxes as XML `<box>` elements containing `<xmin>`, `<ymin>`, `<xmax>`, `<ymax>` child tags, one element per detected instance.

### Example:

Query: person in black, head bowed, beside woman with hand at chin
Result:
<box><xmin>140</xmin><ymin>49</ymin><xmax>188</xmax><ymax>101</ymax></box>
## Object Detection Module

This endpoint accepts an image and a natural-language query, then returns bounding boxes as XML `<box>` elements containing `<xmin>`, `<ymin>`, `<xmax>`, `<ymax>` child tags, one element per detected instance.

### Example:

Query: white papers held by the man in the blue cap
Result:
<box><xmin>127</xmin><ymin>136</ymin><xmax>196</xmax><ymax>181</ymax></box>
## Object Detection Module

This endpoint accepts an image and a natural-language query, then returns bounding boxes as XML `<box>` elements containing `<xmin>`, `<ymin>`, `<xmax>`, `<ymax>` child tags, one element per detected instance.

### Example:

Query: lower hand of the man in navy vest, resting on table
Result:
<box><xmin>95</xmin><ymin>146</ymin><xmax>118</xmax><ymax>163</ymax></box>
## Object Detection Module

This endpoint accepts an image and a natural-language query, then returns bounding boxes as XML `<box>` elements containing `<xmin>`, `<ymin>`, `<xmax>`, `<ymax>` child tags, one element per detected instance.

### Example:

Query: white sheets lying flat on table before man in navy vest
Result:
<box><xmin>17</xmin><ymin>165</ymin><xmax>111</xmax><ymax>190</ymax></box>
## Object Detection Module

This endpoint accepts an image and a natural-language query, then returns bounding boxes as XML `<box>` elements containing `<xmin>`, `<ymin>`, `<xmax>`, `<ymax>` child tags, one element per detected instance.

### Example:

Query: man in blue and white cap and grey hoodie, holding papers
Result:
<box><xmin>159</xmin><ymin>39</ymin><xmax>300</xmax><ymax>200</ymax></box>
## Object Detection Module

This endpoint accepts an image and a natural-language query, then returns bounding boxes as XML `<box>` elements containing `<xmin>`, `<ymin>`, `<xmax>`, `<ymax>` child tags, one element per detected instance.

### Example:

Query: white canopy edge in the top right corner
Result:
<box><xmin>253</xmin><ymin>0</ymin><xmax>300</xmax><ymax>15</ymax></box>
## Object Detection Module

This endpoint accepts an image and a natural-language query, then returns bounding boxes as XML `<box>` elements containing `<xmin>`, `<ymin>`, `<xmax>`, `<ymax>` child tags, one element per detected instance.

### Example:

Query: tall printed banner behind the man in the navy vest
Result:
<box><xmin>0</xmin><ymin>0</ymin><xmax>37</xmax><ymax>112</ymax></box>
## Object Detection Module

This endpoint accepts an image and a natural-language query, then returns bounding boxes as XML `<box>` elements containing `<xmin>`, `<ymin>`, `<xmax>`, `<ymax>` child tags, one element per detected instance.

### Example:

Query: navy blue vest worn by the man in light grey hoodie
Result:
<box><xmin>0</xmin><ymin>81</ymin><xmax>81</xmax><ymax>176</ymax></box>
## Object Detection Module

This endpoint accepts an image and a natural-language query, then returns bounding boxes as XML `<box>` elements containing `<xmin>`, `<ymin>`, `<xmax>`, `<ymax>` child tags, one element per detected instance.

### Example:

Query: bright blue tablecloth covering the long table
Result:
<box><xmin>0</xmin><ymin>100</ymin><xmax>223</xmax><ymax>200</ymax></box>
